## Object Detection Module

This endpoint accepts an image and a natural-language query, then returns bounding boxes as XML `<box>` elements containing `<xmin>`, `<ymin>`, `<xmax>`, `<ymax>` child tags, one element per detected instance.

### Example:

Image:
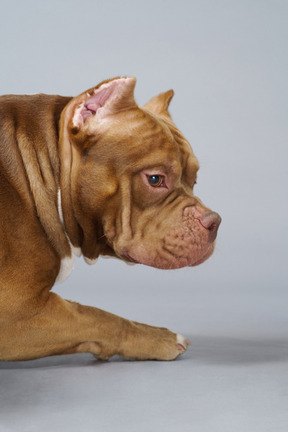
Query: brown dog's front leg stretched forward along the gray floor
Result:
<box><xmin>0</xmin><ymin>293</ymin><xmax>188</xmax><ymax>360</ymax></box>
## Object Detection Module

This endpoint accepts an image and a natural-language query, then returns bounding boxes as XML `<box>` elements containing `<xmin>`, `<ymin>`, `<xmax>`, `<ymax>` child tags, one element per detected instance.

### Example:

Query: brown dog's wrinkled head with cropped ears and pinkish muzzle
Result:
<box><xmin>60</xmin><ymin>78</ymin><xmax>221</xmax><ymax>269</ymax></box>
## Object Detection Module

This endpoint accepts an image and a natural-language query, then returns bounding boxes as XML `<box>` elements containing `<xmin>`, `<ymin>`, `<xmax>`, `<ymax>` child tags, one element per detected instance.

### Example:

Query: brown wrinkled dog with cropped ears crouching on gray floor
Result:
<box><xmin>0</xmin><ymin>78</ymin><xmax>220</xmax><ymax>360</ymax></box>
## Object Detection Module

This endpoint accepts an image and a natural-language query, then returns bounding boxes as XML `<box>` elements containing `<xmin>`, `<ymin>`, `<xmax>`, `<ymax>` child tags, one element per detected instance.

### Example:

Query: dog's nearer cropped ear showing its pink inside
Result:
<box><xmin>67</xmin><ymin>78</ymin><xmax>136</xmax><ymax>134</ymax></box>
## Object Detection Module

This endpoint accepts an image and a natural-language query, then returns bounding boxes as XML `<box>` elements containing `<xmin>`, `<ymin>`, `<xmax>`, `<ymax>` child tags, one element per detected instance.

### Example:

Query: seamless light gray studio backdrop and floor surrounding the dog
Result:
<box><xmin>0</xmin><ymin>0</ymin><xmax>288</xmax><ymax>432</ymax></box>
